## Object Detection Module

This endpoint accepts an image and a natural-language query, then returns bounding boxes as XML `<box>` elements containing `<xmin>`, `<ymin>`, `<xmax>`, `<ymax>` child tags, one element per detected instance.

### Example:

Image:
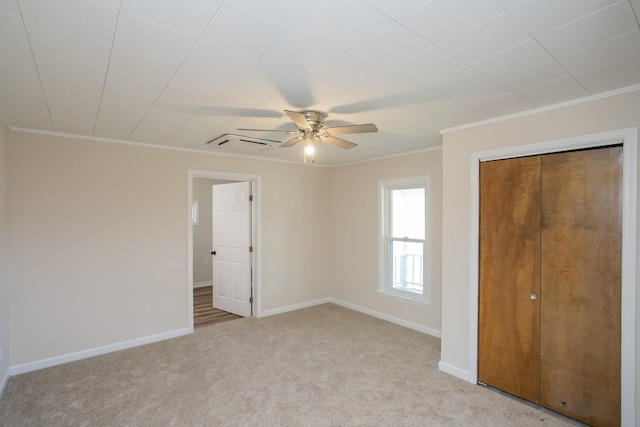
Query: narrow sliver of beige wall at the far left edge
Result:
<box><xmin>0</xmin><ymin>120</ymin><xmax>10</xmax><ymax>384</ymax></box>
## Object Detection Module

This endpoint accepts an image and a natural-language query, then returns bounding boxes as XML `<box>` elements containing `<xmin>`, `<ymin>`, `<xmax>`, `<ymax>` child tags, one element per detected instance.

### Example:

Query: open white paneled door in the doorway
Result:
<box><xmin>212</xmin><ymin>182</ymin><xmax>251</xmax><ymax>317</ymax></box>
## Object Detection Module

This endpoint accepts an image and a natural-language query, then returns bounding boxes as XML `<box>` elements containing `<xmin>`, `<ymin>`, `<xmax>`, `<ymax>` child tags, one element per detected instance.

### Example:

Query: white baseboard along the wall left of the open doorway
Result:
<box><xmin>8</xmin><ymin>328</ymin><xmax>193</xmax><ymax>375</ymax></box>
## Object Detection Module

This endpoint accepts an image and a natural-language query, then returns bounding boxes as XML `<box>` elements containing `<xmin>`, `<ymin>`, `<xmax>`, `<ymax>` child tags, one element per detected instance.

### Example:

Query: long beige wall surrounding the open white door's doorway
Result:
<box><xmin>8</xmin><ymin>132</ymin><xmax>329</xmax><ymax>366</ymax></box>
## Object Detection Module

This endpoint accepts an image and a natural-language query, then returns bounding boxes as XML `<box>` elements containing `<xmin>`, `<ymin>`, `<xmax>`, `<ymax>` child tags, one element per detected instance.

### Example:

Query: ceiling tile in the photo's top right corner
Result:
<box><xmin>537</xmin><ymin>1</ymin><xmax>638</xmax><ymax>57</ymax></box>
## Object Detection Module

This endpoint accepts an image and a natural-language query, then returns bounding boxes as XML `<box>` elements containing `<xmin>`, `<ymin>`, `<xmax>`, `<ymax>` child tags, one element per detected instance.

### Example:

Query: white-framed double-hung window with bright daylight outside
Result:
<box><xmin>378</xmin><ymin>176</ymin><xmax>429</xmax><ymax>305</ymax></box>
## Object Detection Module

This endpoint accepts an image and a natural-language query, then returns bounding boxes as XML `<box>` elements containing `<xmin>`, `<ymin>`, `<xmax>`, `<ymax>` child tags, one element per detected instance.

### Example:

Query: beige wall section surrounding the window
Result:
<box><xmin>330</xmin><ymin>149</ymin><xmax>442</xmax><ymax>334</ymax></box>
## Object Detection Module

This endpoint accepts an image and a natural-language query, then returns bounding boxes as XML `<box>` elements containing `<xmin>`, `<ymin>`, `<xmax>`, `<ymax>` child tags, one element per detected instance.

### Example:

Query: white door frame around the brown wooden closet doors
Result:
<box><xmin>468</xmin><ymin>127</ymin><xmax>638</xmax><ymax>425</ymax></box>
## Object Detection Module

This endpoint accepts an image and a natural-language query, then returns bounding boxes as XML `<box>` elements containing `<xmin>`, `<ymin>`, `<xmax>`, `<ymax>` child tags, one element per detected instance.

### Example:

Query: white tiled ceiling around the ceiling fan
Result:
<box><xmin>0</xmin><ymin>0</ymin><xmax>640</xmax><ymax>164</ymax></box>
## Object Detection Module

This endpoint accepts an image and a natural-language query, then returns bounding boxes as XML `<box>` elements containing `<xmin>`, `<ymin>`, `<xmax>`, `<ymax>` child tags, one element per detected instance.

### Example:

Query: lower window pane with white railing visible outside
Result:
<box><xmin>389</xmin><ymin>240</ymin><xmax>424</xmax><ymax>294</ymax></box>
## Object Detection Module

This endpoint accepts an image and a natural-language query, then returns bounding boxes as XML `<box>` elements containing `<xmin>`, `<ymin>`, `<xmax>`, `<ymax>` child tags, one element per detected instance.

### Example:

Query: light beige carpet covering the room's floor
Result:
<box><xmin>0</xmin><ymin>304</ymin><xmax>576</xmax><ymax>427</ymax></box>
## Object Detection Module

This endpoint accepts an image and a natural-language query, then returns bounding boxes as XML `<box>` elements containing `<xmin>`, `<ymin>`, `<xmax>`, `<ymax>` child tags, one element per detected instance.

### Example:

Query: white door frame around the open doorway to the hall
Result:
<box><xmin>186</xmin><ymin>169</ymin><xmax>262</xmax><ymax>332</ymax></box>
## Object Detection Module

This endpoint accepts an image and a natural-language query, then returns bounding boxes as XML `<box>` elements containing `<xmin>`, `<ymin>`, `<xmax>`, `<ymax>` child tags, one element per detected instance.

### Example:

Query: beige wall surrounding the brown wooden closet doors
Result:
<box><xmin>441</xmin><ymin>91</ymin><xmax>640</xmax><ymax>408</ymax></box>
